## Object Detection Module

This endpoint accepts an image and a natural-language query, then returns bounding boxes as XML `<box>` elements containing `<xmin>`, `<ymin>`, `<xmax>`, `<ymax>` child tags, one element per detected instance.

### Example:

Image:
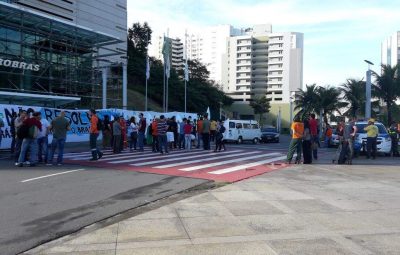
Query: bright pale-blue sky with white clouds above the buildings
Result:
<box><xmin>127</xmin><ymin>0</ymin><xmax>400</xmax><ymax>86</ymax></box>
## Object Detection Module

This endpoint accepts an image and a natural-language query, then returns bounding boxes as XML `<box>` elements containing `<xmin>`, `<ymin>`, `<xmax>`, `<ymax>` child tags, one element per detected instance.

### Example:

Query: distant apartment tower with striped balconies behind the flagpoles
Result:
<box><xmin>149</xmin><ymin>36</ymin><xmax>184</xmax><ymax>70</ymax></box>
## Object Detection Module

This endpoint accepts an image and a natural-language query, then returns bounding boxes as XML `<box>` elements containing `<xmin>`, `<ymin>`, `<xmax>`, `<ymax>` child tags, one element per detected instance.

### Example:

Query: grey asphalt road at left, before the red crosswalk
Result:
<box><xmin>0</xmin><ymin>160</ymin><xmax>207</xmax><ymax>255</ymax></box>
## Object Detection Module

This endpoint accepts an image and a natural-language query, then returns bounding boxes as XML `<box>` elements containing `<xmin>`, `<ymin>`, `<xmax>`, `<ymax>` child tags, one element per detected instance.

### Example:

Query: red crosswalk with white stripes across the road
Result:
<box><xmin>64</xmin><ymin>148</ymin><xmax>285</xmax><ymax>181</ymax></box>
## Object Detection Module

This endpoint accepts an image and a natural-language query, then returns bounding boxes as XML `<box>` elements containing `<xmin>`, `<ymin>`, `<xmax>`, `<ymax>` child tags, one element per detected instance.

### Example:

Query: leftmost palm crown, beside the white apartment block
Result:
<box><xmin>294</xmin><ymin>84</ymin><xmax>319</xmax><ymax>117</ymax></box>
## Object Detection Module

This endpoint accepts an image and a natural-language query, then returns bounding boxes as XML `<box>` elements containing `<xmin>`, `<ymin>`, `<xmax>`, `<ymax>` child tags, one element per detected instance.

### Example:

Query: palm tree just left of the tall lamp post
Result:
<box><xmin>340</xmin><ymin>79</ymin><xmax>365</xmax><ymax>118</ymax></box>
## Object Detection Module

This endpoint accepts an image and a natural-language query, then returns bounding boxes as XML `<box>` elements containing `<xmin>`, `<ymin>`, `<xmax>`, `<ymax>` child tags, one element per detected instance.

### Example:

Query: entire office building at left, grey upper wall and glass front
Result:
<box><xmin>0</xmin><ymin>0</ymin><xmax>127</xmax><ymax>107</ymax></box>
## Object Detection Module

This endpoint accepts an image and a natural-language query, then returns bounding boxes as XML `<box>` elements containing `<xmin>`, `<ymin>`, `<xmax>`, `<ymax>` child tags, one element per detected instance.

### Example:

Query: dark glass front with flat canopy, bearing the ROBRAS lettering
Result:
<box><xmin>0</xmin><ymin>0</ymin><xmax>126</xmax><ymax>108</ymax></box>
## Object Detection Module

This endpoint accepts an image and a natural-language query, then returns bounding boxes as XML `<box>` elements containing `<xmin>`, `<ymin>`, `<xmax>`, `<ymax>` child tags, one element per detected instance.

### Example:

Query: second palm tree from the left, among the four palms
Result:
<box><xmin>314</xmin><ymin>85</ymin><xmax>346</xmax><ymax>124</ymax></box>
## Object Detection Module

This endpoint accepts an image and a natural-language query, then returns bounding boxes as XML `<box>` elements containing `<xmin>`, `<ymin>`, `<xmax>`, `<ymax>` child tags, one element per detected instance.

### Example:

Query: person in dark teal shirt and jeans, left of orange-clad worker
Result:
<box><xmin>47</xmin><ymin>111</ymin><xmax>71</xmax><ymax>166</ymax></box>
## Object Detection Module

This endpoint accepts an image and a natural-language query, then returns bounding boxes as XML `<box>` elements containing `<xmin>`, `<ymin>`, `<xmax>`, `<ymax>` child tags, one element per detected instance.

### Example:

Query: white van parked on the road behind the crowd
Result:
<box><xmin>224</xmin><ymin>119</ymin><xmax>261</xmax><ymax>143</ymax></box>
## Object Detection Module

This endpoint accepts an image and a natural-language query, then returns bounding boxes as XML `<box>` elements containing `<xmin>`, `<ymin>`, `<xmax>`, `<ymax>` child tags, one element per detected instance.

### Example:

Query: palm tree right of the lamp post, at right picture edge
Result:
<box><xmin>372</xmin><ymin>65</ymin><xmax>400</xmax><ymax>125</ymax></box>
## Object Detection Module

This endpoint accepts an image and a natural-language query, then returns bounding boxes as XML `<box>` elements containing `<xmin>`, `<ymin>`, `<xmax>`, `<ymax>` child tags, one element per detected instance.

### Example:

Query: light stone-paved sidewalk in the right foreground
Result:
<box><xmin>27</xmin><ymin>158</ymin><xmax>400</xmax><ymax>255</ymax></box>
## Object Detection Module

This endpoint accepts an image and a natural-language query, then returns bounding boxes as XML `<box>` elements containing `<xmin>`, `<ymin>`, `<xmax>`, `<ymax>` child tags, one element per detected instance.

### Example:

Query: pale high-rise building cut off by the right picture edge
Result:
<box><xmin>381</xmin><ymin>31</ymin><xmax>400</xmax><ymax>66</ymax></box>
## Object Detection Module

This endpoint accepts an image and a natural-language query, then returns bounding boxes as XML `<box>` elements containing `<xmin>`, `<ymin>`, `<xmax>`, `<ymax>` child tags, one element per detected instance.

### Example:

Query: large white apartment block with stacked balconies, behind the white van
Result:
<box><xmin>223</xmin><ymin>25</ymin><xmax>303</xmax><ymax>104</ymax></box>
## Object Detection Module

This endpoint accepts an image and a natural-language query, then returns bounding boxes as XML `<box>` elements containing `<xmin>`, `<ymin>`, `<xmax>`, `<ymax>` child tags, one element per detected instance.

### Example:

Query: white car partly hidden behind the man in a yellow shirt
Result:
<box><xmin>356</xmin><ymin>121</ymin><xmax>392</xmax><ymax>155</ymax></box>
